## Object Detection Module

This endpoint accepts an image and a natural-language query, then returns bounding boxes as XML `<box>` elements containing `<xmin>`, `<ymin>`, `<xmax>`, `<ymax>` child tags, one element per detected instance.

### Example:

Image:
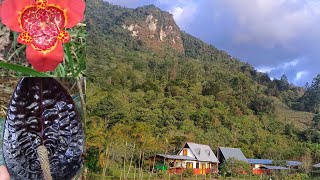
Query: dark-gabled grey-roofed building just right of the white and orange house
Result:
<box><xmin>217</xmin><ymin>147</ymin><xmax>248</xmax><ymax>163</ymax></box>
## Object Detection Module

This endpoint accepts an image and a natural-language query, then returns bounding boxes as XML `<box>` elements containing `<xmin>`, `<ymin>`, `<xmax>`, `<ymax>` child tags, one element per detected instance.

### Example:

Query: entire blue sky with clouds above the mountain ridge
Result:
<box><xmin>107</xmin><ymin>0</ymin><xmax>320</xmax><ymax>86</ymax></box>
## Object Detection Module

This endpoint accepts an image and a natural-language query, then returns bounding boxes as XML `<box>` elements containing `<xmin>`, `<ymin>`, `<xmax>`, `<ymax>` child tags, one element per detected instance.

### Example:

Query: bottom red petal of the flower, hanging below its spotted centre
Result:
<box><xmin>27</xmin><ymin>43</ymin><xmax>64</xmax><ymax>72</ymax></box>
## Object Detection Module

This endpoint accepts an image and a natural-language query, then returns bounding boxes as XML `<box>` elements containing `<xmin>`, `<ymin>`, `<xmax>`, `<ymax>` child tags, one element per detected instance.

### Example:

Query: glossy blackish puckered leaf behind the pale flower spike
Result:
<box><xmin>3</xmin><ymin>78</ymin><xmax>84</xmax><ymax>180</ymax></box>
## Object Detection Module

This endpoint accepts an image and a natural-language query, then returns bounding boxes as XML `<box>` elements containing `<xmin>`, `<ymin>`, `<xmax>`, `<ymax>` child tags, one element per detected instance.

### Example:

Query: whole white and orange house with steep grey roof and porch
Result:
<box><xmin>150</xmin><ymin>142</ymin><xmax>219</xmax><ymax>174</ymax></box>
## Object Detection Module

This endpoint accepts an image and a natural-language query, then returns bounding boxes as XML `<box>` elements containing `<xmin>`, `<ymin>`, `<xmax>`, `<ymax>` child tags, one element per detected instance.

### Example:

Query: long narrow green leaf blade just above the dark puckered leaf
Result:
<box><xmin>0</xmin><ymin>62</ymin><xmax>50</xmax><ymax>77</ymax></box>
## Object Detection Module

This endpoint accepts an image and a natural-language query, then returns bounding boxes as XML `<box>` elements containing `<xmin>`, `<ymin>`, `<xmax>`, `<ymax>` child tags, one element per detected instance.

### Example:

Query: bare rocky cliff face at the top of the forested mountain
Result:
<box><xmin>122</xmin><ymin>5</ymin><xmax>184</xmax><ymax>52</ymax></box>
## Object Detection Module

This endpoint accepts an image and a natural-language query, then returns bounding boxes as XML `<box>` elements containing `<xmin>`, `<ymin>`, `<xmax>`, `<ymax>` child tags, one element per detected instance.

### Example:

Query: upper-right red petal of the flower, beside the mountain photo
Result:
<box><xmin>49</xmin><ymin>0</ymin><xmax>86</xmax><ymax>28</ymax></box>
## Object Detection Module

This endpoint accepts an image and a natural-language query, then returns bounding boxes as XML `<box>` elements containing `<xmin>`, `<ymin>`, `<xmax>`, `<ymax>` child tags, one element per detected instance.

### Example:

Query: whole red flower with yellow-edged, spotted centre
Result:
<box><xmin>0</xmin><ymin>0</ymin><xmax>85</xmax><ymax>72</ymax></box>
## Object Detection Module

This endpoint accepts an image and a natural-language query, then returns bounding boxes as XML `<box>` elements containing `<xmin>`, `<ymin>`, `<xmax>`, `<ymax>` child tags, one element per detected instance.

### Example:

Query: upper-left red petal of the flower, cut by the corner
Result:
<box><xmin>0</xmin><ymin>0</ymin><xmax>35</xmax><ymax>32</ymax></box>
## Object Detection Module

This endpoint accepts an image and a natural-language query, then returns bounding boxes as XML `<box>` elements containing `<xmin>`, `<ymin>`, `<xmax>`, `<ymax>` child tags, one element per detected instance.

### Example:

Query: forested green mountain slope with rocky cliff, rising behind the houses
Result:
<box><xmin>86</xmin><ymin>0</ymin><xmax>320</xmax><ymax>177</ymax></box>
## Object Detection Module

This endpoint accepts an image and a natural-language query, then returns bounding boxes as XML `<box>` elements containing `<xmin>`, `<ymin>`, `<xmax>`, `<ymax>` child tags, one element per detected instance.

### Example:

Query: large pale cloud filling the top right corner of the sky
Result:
<box><xmin>220</xmin><ymin>0</ymin><xmax>320</xmax><ymax>48</ymax></box>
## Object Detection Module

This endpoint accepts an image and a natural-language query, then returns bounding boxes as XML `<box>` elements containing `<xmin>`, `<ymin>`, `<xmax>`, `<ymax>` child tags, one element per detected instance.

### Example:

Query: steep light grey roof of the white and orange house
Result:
<box><xmin>180</xmin><ymin>142</ymin><xmax>219</xmax><ymax>163</ymax></box>
